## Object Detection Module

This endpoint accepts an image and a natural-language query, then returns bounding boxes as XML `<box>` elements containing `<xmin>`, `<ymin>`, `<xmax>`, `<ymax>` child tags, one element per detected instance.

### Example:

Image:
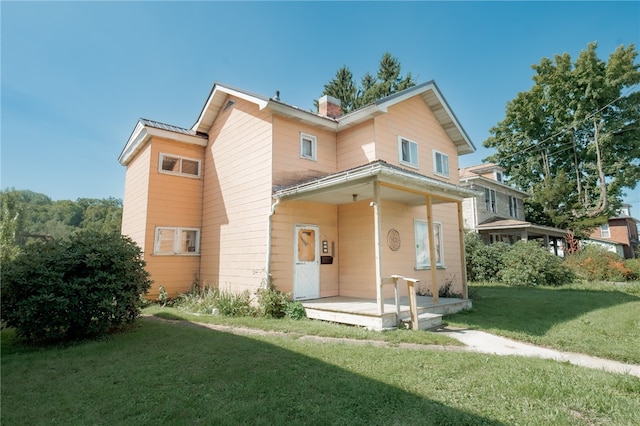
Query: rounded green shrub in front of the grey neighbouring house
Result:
<box><xmin>500</xmin><ymin>241</ymin><xmax>574</xmax><ymax>287</ymax></box>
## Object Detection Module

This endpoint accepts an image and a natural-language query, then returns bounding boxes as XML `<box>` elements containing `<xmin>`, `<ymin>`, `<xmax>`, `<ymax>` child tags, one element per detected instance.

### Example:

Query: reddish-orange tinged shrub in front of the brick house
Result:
<box><xmin>565</xmin><ymin>244</ymin><xmax>633</xmax><ymax>281</ymax></box>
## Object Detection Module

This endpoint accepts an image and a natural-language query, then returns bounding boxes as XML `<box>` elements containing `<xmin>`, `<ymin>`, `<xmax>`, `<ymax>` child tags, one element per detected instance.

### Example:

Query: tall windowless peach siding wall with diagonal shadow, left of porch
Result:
<box><xmin>200</xmin><ymin>99</ymin><xmax>272</xmax><ymax>292</ymax></box>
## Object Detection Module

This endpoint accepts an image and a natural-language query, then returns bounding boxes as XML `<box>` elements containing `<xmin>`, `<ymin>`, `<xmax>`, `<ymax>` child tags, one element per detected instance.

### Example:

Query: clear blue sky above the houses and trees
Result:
<box><xmin>0</xmin><ymin>1</ymin><xmax>640</xmax><ymax>212</ymax></box>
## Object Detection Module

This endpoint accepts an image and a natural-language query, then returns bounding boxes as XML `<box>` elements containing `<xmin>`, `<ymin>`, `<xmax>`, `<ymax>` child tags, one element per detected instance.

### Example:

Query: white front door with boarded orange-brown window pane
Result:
<box><xmin>293</xmin><ymin>225</ymin><xmax>320</xmax><ymax>300</ymax></box>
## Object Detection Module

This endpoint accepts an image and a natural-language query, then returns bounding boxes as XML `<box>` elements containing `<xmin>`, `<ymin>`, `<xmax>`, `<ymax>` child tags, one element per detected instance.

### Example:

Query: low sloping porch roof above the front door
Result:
<box><xmin>274</xmin><ymin>160</ymin><xmax>479</xmax><ymax>205</ymax></box>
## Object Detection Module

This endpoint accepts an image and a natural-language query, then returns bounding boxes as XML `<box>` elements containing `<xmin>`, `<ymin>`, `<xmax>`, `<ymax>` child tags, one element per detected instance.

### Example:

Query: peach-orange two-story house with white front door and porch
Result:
<box><xmin>119</xmin><ymin>81</ymin><xmax>475</xmax><ymax>330</ymax></box>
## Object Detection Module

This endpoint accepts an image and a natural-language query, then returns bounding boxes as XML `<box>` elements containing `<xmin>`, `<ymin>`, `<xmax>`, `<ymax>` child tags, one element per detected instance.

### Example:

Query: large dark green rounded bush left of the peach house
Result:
<box><xmin>1</xmin><ymin>231</ymin><xmax>151</xmax><ymax>341</ymax></box>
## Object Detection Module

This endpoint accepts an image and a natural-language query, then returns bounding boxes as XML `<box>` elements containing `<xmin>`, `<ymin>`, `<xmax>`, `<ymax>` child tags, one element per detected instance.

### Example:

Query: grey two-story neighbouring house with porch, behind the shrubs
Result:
<box><xmin>458</xmin><ymin>163</ymin><xmax>567</xmax><ymax>255</ymax></box>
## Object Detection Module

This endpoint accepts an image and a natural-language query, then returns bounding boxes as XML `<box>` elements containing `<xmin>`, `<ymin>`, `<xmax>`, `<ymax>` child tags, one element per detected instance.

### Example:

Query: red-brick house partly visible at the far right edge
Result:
<box><xmin>586</xmin><ymin>204</ymin><xmax>640</xmax><ymax>259</ymax></box>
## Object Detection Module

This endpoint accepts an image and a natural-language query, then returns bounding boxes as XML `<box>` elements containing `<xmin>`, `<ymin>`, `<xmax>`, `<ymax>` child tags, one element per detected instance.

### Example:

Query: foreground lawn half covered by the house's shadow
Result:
<box><xmin>0</xmin><ymin>318</ymin><xmax>640</xmax><ymax>425</ymax></box>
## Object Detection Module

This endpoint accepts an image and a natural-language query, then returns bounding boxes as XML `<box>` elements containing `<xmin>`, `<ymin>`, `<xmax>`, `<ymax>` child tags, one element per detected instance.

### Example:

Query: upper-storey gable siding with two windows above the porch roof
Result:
<box><xmin>375</xmin><ymin>96</ymin><xmax>459</xmax><ymax>184</ymax></box>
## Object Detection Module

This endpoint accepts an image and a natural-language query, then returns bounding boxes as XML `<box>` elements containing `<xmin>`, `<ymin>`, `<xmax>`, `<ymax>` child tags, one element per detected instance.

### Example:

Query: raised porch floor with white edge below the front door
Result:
<box><xmin>301</xmin><ymin>296</ymin><xmax>472</xmax><ymax>330</ymax></box>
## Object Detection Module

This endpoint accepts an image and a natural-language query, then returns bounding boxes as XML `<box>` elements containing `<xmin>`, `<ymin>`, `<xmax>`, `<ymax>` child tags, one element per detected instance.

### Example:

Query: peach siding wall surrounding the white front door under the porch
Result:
<box><xmin>271</xmin><ymin>201</ymin><xmax>340</xmax><ymax>297</ymax></box>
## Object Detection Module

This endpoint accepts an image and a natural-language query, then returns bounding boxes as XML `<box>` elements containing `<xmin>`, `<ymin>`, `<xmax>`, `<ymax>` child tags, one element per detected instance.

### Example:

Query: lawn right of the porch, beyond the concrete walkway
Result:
<box><xmin>446</xmin><ymin>282</ymin><xmax>640</xmax><ymax>364</ymax></box>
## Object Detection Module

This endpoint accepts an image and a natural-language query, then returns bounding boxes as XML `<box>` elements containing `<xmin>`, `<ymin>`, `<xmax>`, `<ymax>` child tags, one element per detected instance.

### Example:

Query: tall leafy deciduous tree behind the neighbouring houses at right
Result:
<box><xmin>484</xmin><ymin>43</ymin><xmax>640</xmax><ymax>232</ymax></box>
